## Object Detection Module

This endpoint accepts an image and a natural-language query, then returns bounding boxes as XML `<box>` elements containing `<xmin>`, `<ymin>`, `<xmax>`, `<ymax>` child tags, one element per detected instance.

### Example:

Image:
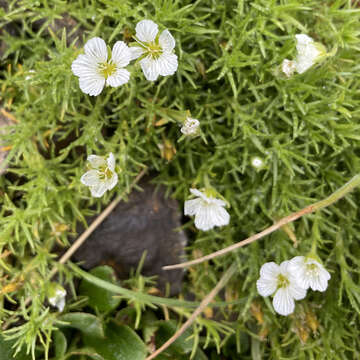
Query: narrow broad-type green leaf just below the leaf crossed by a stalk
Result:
<box><xmin>59</xmin><ymin>312</ymin><xmax>104</xmax><ymax>338</ymax></box>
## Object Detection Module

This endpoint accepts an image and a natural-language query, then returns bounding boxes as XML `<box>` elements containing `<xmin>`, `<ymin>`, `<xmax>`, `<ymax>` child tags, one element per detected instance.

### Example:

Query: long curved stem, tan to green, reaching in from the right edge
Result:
<box><xmin>163</xmin><ymin>174</ymin><xmax>360</xmax><ymax>270</ymax></box>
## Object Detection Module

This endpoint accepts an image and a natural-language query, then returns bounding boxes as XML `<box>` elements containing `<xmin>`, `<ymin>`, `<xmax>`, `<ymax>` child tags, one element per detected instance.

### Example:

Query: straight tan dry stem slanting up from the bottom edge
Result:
<box><xmin>145</xmin><ymin>262</ymin><xmax>237</xmax><ymax>360</ymax></box>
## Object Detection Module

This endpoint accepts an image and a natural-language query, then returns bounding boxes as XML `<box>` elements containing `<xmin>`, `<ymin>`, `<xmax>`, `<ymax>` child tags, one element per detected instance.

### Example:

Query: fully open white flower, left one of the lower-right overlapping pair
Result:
<box><xmin>256</xmin><ymin>261</ymin><xmax>306</xmax><ymax>316</ymax></box>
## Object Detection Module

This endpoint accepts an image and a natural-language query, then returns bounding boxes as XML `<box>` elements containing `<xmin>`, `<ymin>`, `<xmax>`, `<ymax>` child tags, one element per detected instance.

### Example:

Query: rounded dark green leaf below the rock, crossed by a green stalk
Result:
<box><xmin>79</xmin><ymin>266</ymin><xmax>121</xmax><ymax>313</ymax></box>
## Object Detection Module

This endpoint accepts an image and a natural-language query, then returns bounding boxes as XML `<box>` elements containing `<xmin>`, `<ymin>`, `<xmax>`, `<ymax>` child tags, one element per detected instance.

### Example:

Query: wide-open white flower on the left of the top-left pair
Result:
<box><xmin>71</xmin><ymin>37</ymin><xmax>131</xmax><ymax>96</ymax></box>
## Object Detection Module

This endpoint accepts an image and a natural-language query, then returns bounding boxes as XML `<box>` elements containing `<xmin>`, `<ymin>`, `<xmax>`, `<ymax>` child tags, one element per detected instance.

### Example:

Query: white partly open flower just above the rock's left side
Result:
<box><xmin>80</xmin><ymin>153</ymin><xmax>118</xmax><ymax>197</ymax></box>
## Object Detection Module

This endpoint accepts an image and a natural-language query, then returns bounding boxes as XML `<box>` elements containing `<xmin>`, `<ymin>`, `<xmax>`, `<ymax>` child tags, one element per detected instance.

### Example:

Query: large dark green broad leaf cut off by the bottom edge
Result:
<box><xmin>84</xmin><ymin>323</ymin><xmax>147</xmax><ymax>360</ymax></box>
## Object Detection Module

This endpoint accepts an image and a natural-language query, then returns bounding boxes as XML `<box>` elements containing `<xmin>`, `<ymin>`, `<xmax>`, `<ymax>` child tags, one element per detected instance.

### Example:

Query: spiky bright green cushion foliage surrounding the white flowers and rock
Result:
<box><xmin>0</xmin><ymin>0</ymin><xmax>360</xmax><ymax>359</ymax></box>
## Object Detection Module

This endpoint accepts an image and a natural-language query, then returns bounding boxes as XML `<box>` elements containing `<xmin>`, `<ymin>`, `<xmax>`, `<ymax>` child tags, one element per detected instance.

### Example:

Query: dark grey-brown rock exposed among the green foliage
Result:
<box><xmin>73</xmin><ymin>182</ymin><xmax>187</xmax><ymax>295</ymax></box>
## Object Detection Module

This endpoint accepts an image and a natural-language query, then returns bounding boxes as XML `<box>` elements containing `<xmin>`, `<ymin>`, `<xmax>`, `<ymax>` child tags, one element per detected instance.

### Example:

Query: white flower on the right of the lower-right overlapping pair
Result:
<box><xmin>290</xmin><ymin>256</ymin><xmax>331</xmax><ymax>291</ymax></box>
